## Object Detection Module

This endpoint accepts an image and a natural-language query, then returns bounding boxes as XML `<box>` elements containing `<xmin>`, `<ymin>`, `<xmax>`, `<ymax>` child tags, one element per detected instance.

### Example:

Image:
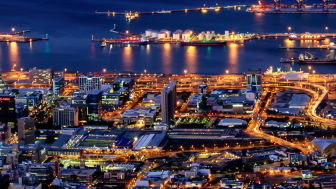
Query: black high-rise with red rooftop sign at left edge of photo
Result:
<box><xmin>0</xmin><ymin>94</ymin><xmax>16</xmax><ymax>127</ymax></box>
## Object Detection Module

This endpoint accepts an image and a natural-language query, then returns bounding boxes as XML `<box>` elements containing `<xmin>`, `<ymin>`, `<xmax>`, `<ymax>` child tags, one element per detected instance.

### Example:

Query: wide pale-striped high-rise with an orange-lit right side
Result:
<box><xmin>53</xmin><ymin>103</ymin><xmax>78</xmax><ymax>127</ymax></box>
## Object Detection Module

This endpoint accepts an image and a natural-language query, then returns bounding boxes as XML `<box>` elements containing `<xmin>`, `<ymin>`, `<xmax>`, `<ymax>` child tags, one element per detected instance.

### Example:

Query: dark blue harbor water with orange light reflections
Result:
<box><xmin>0</xmin><ymin>0</ymin><xmax>336</xmax><ymax>74</ymax></box>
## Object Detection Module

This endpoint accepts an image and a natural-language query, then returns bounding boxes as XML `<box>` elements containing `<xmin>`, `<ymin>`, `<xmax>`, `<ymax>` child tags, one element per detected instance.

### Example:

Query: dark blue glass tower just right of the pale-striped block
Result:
<box><xmin>87</xmin><ymin>90</ymin><xmax>102</xmax><ymax>121</ymax></box>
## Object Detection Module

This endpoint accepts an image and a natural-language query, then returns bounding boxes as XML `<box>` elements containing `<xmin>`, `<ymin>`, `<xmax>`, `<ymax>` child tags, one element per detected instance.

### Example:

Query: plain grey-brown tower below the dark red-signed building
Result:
<box><xmin>18</xmin><ymin>117</ymin><xmax>35</xmax><ymax>144</ymax></box>
